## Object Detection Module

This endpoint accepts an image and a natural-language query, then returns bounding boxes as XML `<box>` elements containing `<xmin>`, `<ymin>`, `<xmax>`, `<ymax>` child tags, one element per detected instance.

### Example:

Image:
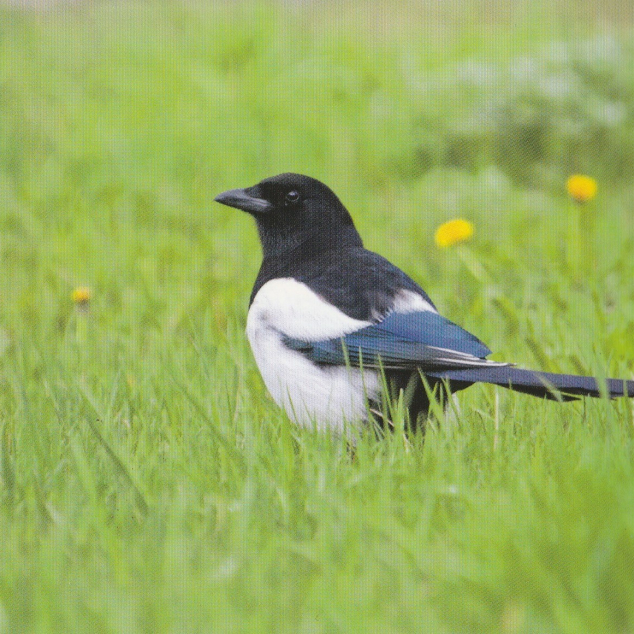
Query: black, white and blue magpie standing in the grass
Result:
<box><xmin>215</xmin><ymin>173</ymin><xmax>634</xmax><ymax>434</ymax></box>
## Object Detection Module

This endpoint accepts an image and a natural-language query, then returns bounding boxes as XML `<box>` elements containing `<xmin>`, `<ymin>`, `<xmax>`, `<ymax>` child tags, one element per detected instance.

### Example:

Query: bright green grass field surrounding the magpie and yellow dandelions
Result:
<box><xmin>0</xmin><ymin>0</ymin><xmax>634</xmax><ymax>634</ymax></box>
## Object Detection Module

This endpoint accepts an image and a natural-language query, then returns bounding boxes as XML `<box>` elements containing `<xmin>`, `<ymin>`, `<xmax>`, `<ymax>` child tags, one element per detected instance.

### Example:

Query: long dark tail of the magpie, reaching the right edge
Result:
<box><xmin>430</xmin><ymin>366</ymin><xmax>634</xmax><ymax>400</ymax></box>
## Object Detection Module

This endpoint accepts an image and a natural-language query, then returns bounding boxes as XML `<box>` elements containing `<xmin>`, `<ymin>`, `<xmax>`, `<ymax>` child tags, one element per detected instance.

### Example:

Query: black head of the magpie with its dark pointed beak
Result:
<box><xmin>215</xmin><ymin>173</ymin><xmax>362</xmax><ymax>258</ymax></box>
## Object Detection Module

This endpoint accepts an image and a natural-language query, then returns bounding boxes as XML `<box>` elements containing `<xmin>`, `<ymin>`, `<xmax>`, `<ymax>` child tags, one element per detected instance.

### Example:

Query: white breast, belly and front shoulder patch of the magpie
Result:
<box><xmin>247</xmin><ymin>278</ymin><xmax>381</xmax><ymax>432</ymax></box>
